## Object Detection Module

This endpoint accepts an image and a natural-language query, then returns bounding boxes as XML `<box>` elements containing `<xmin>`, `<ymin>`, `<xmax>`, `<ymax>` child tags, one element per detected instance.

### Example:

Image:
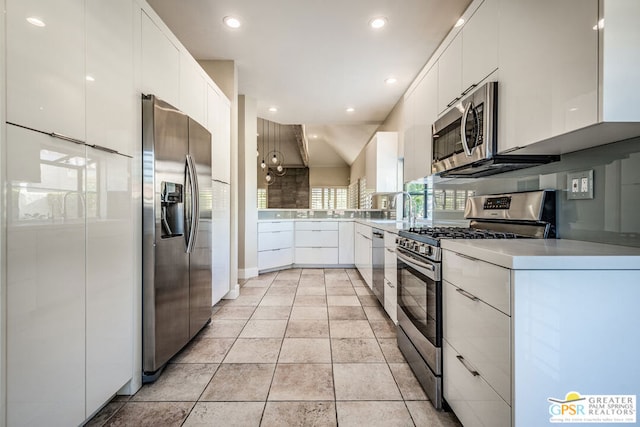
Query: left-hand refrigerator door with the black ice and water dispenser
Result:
<box><xmin>142</xmin><ymin>96</ymin><xmax>190</xmax><ymax>373</ymax></box>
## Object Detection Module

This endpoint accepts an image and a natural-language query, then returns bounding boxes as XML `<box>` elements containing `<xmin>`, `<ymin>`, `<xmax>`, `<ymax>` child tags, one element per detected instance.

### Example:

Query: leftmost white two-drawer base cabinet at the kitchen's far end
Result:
<box><xmin>258</xmin><ymin>221</ymin><xmax>293</xmax><ymax>271</ymax></box>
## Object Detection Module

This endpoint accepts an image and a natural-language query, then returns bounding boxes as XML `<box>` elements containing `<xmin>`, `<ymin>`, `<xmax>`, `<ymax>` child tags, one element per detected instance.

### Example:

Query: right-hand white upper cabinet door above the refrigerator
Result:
<box><xmin>180</xmin><ymin>52</ymin><xmax>207</xmax><ymax>126</ymax></box>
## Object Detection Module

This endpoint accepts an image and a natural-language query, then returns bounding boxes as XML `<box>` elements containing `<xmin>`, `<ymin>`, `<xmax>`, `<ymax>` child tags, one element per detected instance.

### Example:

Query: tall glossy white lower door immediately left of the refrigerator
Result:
<box><xmin>85</xmin><ymin>148</ymin><xmax>136</xmax><ymax>417</ymax></box>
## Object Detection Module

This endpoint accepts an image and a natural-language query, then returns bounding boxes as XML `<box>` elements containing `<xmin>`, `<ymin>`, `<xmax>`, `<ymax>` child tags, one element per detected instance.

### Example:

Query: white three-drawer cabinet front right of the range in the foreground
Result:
<box><xmin>442</xmin><ymin>250</ymin><xmax>512</xmax><ymax>426</ymax></box>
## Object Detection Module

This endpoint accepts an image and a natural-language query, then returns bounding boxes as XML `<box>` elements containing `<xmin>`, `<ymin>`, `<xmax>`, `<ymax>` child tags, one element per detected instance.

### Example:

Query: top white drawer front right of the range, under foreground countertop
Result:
<box><xmin>442</xmin><ymin>251</ymin><xmax>511</xmax><ymax>315</ymax></box>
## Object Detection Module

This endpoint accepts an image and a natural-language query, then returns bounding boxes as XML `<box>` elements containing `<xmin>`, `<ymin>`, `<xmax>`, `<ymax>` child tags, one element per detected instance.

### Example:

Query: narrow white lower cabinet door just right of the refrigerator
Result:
<box><xmin>211</xmin><ymin>181</ymin><xmax>231</xmax><ymax>304</ymax></box>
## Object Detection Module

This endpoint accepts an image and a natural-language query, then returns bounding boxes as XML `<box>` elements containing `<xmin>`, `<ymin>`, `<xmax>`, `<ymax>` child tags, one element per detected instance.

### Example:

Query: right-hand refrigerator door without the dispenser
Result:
<box><xmin>189</xmin><ymin>119</ymin><xmax>212</xmax><ymax>337</ymax></box>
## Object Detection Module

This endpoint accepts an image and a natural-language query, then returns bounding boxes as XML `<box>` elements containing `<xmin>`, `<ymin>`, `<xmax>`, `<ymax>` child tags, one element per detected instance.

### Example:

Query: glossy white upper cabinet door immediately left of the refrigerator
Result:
<box><xmin>85</xmin><ymin>0</ymin><xmax>135</xmax><ymax>156</ymax></box>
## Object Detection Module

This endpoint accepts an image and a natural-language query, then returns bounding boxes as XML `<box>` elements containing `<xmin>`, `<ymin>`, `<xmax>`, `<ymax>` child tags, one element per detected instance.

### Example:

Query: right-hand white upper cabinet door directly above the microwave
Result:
<box><xmin>461</xmin><ymin>0</ymin><xmax>500</xmax><ymax>93</ymax></box>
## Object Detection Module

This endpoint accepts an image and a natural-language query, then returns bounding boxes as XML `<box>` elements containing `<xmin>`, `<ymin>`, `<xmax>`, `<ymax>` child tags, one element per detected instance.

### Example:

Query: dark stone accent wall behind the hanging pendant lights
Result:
<box><xmin>267</xmin><ymin>168</ymin><xmax>310</xmax><ymax>209</ymax></box>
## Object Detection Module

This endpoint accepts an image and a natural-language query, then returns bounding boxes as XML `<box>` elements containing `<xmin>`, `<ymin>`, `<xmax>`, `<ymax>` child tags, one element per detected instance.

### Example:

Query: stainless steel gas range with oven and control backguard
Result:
<box><xmin>396</xmin><ymin>190</ymin><xmax>556</xmax><ymax>409</ymax></box>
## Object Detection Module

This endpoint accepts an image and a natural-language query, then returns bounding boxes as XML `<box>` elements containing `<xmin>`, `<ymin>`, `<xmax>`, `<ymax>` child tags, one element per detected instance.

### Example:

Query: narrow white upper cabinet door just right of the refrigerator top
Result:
<box><xmin>207</xmin><ymin>85</ymin><xmax>231</xmax><ymax>183</ymax></box>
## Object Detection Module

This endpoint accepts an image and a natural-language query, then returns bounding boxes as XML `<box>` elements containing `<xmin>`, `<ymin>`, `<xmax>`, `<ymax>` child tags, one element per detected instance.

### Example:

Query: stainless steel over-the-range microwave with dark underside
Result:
<box><xmin>431</xmin><ymin>82</ymin><xmax>560</xmax><ymax>178</ymax></box>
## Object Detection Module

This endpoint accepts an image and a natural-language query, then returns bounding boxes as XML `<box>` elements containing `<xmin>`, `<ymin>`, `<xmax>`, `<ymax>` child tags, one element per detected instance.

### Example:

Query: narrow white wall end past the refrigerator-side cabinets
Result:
<box><xmin>237</xmin><ymin>95</ymin><xmax>258</xmax><ymax>279</ymax></box>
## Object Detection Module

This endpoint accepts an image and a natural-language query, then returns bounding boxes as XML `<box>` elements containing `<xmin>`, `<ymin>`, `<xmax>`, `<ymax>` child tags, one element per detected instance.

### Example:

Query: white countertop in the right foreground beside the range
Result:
<box><xmin>441</xmin><ymin>239</ymin><xmax>640</xmax><ymax>271</ymax></box>
